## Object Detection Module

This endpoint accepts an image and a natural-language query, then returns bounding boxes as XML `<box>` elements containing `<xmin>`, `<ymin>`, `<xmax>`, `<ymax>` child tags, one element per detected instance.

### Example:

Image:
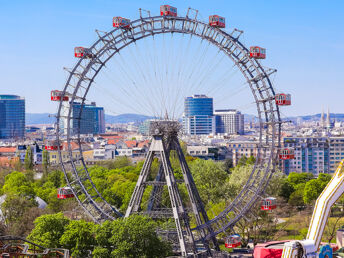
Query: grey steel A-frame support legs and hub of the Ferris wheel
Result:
<box><xmin>125</xmin><ymin>120</ymin><xmax>219</xmax><ymax>256</ymax></box>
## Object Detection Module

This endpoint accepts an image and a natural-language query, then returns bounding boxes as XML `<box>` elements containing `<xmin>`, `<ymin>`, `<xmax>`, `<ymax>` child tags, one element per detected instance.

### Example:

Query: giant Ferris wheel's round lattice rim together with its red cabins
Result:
<box><xmin>51</xmin><ymin>6</ymin><xmax>292</xmax><ymax>252</ymax></box>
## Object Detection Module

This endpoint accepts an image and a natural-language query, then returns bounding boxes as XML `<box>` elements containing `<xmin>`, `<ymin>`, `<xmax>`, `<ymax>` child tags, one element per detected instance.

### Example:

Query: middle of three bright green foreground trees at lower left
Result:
<box><xmin>60</xmin><ymin>220</ymin><xmax>96</xmax><ymax>257</ymax></box>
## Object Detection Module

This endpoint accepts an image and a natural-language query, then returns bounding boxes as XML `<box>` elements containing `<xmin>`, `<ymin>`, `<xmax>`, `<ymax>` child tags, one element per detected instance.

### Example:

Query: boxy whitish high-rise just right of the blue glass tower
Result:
<box><xmin>214</xmin><ymin>109</ymin><xmax>244</xmax><ymax>134</ymax></box>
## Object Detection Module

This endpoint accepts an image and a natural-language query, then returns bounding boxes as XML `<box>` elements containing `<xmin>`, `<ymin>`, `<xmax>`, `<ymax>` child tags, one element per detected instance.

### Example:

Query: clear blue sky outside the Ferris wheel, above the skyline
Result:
<box><xmin>0</xmin><ymin>0</ymin><xmax>344</xmax><ymax>115</ymax></box>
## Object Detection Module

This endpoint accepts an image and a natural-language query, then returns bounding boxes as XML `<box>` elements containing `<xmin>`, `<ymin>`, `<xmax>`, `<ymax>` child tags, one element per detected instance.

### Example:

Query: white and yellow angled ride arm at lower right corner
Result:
<box><xmin>282</xmin><ymin>160</ymin><xmax>344</xmax><ymax>258</ymax></box>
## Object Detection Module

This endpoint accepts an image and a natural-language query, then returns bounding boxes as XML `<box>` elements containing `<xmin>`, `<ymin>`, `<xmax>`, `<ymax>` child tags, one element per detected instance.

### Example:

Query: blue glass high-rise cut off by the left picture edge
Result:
<box><xmin>0</xmin><ymin>95</ymin><xmax>25</xmax><ymax>139</ymax></box>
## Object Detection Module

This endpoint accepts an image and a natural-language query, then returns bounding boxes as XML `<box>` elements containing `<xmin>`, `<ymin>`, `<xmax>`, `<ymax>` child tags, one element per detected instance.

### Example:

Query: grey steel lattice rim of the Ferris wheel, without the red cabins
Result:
<box><xmin>56</xmin><ymin>8</ymin><xmax>281</xmax><ymax>247</ymax></box>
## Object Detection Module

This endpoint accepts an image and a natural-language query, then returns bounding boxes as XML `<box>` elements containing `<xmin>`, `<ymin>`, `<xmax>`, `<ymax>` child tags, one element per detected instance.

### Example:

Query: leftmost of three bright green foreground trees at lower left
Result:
<box><xmin>28</xmin><ymin>213</ymin><xmax>70</xmax><ymax>248</ymax></box>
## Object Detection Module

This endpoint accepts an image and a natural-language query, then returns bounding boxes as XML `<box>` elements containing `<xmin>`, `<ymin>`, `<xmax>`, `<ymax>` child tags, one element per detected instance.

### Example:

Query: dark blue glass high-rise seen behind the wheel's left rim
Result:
<box><xmin>60</xmin><ymin>102</ymin><xmax>105</xmax><ymax>134</ymax></box>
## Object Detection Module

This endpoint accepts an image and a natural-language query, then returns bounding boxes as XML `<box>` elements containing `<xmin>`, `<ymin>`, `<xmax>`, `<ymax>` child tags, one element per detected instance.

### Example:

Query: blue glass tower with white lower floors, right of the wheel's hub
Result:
<box><xmin>183</xmin><ymin>95</ymin><xmax>215</xmax><ymax>135</ymax></box>
